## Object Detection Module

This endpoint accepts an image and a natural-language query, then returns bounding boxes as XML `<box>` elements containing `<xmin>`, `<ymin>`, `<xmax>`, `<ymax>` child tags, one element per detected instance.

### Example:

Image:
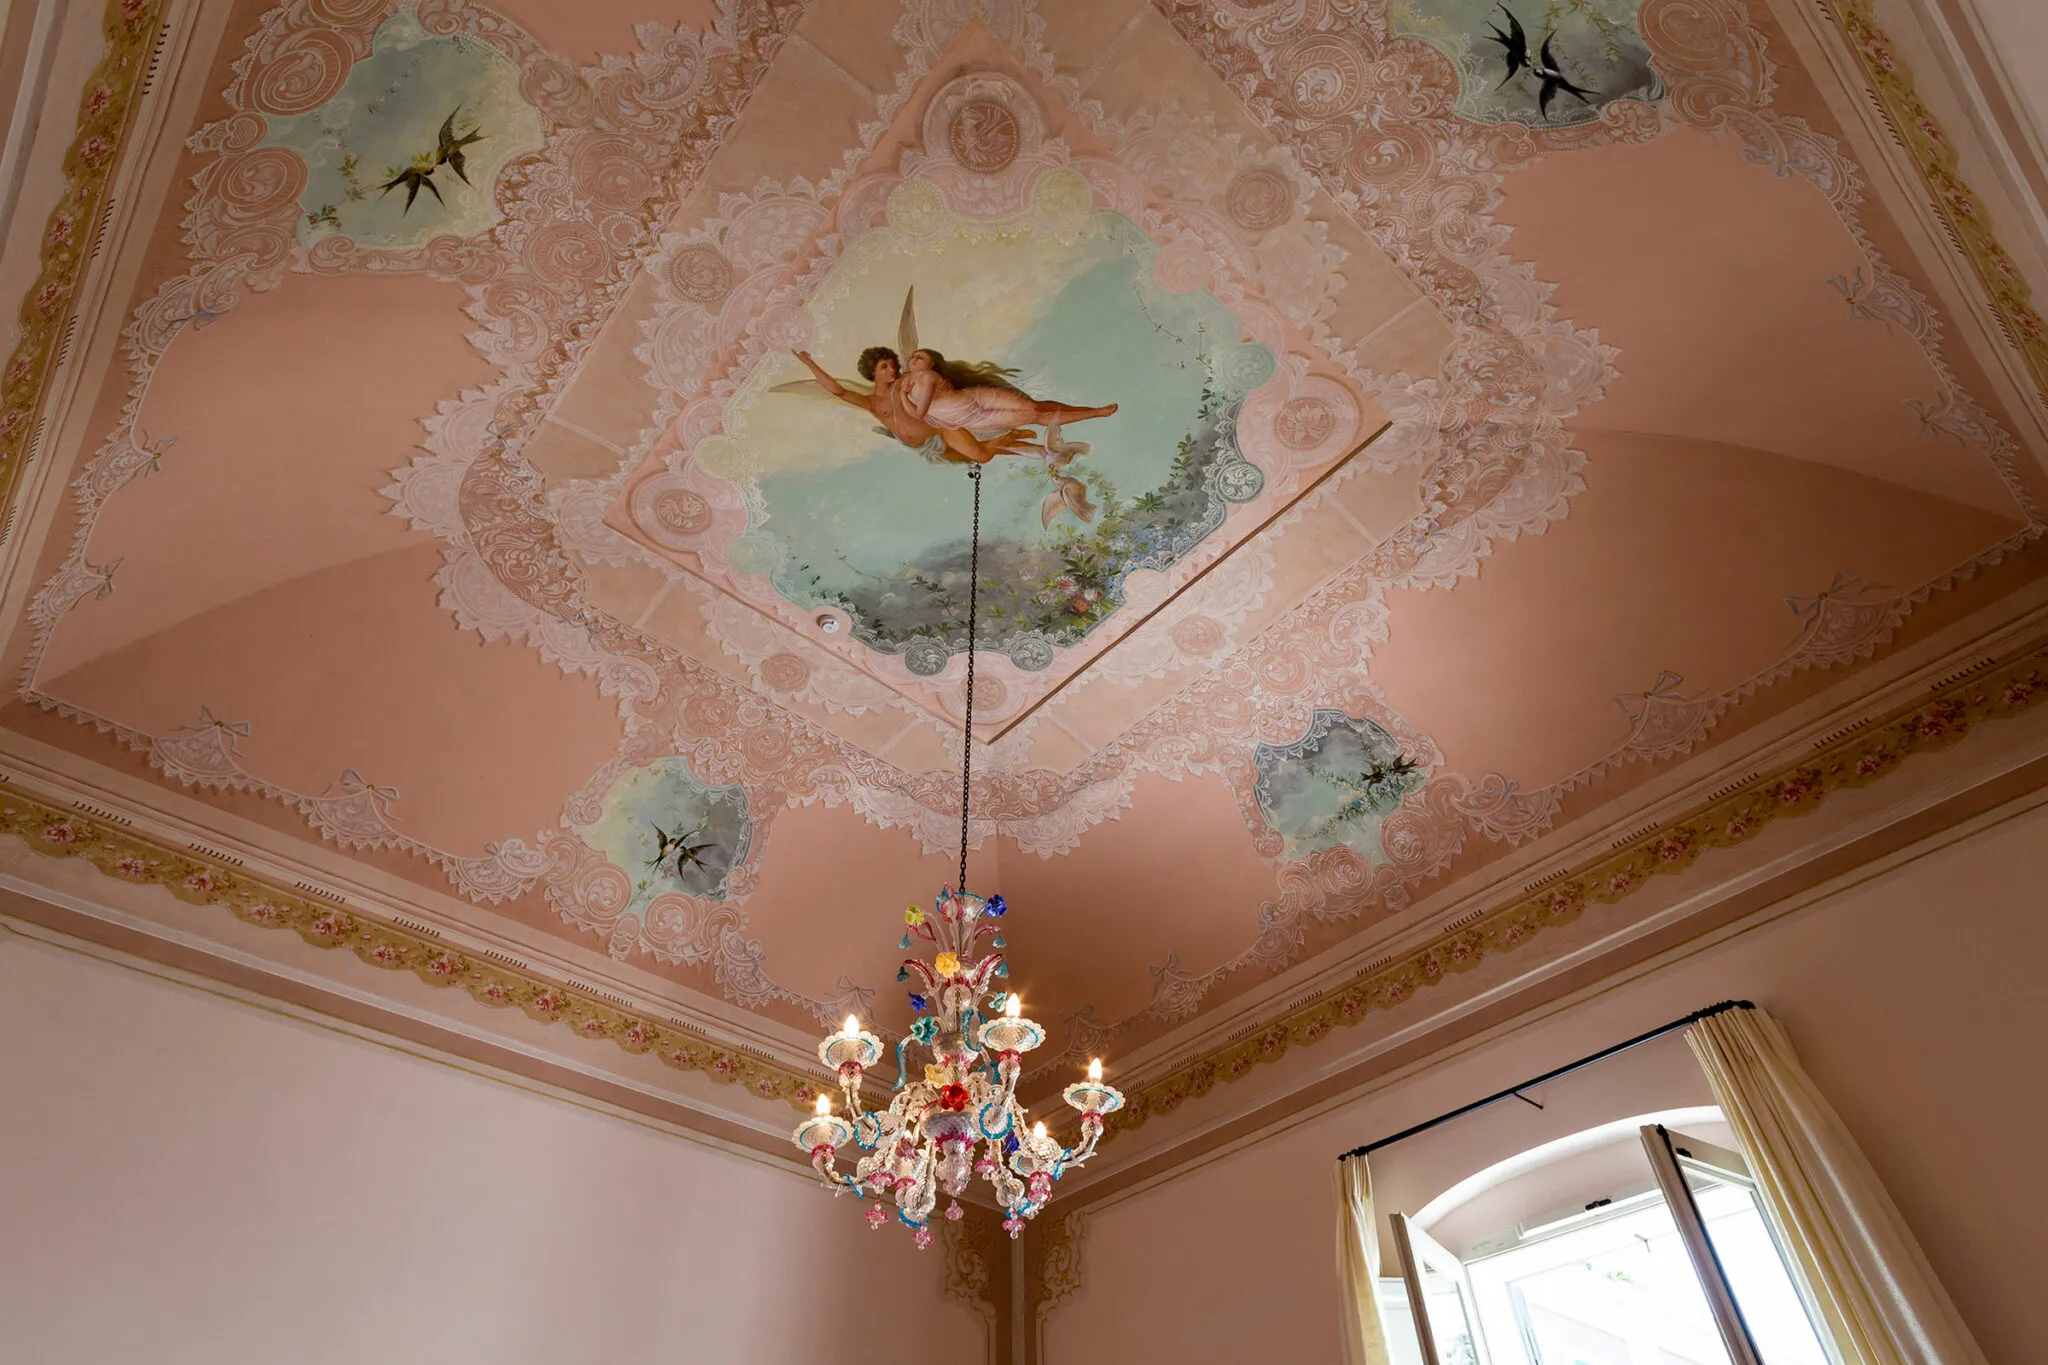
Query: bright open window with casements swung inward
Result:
<box><xmin>1389</xmin><ymin>1115</ymin><xmax>1829</xmax><ymax>1365</ymax></box>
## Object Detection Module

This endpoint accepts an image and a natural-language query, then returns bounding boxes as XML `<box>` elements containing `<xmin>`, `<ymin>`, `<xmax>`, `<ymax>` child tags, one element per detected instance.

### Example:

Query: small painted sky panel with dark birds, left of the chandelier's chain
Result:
<box><xmin>575</xmin><ymin>757</ymin><xmax>754</xmax><ymax>915</ymax></box>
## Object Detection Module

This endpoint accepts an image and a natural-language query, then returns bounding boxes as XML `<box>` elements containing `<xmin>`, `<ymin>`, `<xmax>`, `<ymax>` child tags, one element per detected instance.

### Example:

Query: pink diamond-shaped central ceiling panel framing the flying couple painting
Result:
<box><xmin>606</xmin><ymin>72</ymin><xmax>1362</xmax><ymax>739</ymax></box>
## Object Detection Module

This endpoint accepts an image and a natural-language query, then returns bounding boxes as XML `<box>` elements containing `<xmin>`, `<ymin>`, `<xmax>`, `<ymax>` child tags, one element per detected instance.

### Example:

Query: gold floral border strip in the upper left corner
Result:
<box><xmin>0</xmin><ymin>0</ymin><xmax>164</xmax><ymax>503</ymax></box>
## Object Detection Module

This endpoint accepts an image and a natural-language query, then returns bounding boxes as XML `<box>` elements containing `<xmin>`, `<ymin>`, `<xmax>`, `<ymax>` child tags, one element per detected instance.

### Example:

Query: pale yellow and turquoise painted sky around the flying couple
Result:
<box><xmin>727</xmin><ymin>197</ymin><xmax>1274</xmax><ymax>654</ymax></box>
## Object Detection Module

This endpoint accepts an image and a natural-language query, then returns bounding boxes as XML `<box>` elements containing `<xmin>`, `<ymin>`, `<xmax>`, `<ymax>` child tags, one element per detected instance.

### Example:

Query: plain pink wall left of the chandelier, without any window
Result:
<box><xmin>0</xmin><ymin>935</ymin><xmax>985</xmax><ymax>1365</ymax></box>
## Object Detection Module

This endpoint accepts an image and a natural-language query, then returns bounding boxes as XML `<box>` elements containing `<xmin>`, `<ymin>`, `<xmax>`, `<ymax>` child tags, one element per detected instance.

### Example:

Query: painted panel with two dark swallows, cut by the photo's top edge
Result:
<box><xmin>1393</xmin><ymin>0</ymin><xmax>1663</xmax><ymax>127</ymax></box>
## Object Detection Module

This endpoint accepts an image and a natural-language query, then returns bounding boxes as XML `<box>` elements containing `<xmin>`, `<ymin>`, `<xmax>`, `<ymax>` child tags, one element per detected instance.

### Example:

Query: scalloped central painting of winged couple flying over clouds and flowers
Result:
<box><xmin>720</xmin><ymin>173</ymin><xmax>1274</xmax><ymax>675</ymax></box>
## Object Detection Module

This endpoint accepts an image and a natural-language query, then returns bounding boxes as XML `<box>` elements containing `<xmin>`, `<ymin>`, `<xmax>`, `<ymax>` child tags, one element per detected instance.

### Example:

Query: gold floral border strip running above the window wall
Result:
<box><xmin>1108</xmin><ymin>641</ymin><xmax>2048</xmax><ymax>1136</ymax></box>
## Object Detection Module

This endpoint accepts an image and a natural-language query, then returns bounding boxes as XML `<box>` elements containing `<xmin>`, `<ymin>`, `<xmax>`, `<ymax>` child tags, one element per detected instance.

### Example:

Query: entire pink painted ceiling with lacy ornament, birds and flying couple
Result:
<box><xmin>6</xmin><ymin>0</ymin><xmax>2048</xmax><ymax>1113</ymax></box>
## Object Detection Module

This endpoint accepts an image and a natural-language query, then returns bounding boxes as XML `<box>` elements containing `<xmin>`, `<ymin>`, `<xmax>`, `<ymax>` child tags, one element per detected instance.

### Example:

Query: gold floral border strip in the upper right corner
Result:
<box><xmin>1817</xmin><ymin>0</ymin><xmax>2048</xmax><ymax>399</ymax></box>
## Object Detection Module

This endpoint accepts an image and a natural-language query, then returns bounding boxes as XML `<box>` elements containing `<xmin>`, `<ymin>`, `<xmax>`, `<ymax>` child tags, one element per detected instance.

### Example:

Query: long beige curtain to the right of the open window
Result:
<box><xmin>1686</xmin><ymin>1009</ymin><xmax>1985</xmax><ymax>1365</ymax></box>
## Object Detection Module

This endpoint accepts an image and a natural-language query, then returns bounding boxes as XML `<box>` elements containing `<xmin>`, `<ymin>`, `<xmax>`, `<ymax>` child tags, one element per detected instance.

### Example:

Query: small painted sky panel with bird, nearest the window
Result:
<box><xmin>1251</xmin><ymin>708</ymin><xmax>1430</xmax><ymax>866</ymax></box>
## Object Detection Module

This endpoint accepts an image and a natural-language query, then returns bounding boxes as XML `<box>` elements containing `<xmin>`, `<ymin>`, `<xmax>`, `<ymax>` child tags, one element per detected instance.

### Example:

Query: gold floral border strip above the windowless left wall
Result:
<box><xmin>0</xmin><ymin>782</ymin><xmax>817</xmax><ymax>1109</ymax></box>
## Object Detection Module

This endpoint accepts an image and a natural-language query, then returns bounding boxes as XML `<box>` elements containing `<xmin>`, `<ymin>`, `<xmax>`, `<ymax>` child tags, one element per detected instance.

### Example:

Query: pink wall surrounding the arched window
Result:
<box><xmin>1044</xmin><ymin>806</ymin><xmax>2048</xmax><ymax>1365</ymax></box>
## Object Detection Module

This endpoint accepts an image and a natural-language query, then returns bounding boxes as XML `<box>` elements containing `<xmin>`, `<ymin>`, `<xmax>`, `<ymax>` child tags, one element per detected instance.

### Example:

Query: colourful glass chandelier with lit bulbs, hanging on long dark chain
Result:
<box><xmin>791</xmin><ymin>465</ymin><xmax>1124</xmax><ymax>1248</ymax></box>
